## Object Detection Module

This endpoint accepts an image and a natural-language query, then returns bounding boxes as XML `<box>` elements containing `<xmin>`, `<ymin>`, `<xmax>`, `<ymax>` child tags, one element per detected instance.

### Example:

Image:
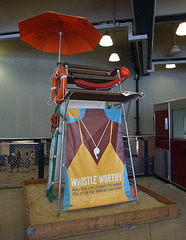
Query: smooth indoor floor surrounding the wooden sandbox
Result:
<box><xmin>0</xmin><ymin>177</ymin><xmax>186</xmax><ymax>240</ymax></box>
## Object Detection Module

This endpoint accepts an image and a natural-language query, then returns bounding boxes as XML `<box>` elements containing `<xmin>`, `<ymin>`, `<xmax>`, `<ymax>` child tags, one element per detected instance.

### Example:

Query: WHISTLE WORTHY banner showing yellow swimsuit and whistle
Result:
<box><xmin>63</xmin><ymin>108</ymin><xmax>134</xmax><ymax>210</ymax></box>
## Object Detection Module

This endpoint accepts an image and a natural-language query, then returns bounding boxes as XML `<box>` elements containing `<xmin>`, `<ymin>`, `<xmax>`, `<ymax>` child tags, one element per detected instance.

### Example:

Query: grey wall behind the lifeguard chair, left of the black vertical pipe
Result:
<box><xmin>0</xmin><ymin>39</ymin><xmax>135</xmax><ymax>138</ymax></box>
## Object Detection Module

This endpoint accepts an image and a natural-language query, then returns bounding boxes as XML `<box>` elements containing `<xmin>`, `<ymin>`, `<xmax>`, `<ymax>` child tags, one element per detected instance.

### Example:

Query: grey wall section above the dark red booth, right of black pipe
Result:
<box><xmin>140</xmin><ymin>64</ymin><xmax>186</xmax><ymax>134</ymax></box>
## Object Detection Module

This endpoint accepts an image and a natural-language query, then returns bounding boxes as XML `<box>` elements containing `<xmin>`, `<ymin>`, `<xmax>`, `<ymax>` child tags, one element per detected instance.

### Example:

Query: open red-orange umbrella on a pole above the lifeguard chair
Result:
<box><xmin>19</xmin><ymin>11</ymin><xmax>102</xmax><ymax>62</ymax></box>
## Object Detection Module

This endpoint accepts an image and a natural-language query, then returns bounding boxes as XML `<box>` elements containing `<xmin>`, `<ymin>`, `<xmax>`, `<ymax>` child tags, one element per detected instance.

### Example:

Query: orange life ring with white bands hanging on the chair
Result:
<box><xmin>51</xmin><ymin>65</ymin><xmax>67</xmax><ymax>104</ymax></box>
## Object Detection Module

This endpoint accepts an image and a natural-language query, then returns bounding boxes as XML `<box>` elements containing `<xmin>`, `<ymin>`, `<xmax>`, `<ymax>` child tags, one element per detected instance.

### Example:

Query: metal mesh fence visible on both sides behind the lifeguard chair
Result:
<box><xmin>0</xmin><ymin>138</ymin><xmax>154</xmax><ymax>187</ymax></box>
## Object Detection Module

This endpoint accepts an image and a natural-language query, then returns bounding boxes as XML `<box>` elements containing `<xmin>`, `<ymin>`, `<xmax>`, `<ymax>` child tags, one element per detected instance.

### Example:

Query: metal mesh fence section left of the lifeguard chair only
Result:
<box><xmin>0</xmin><ymin>141</ymin><xmax>50</xmax><ymax>187</ymax></box>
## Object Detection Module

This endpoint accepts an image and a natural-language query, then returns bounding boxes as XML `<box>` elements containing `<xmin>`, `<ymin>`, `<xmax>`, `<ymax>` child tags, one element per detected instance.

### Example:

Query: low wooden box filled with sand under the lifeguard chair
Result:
<box><xmin>23</xmin><ymin>179</ymin><xmax>180</xmax><ymax>240</ymax></box>
